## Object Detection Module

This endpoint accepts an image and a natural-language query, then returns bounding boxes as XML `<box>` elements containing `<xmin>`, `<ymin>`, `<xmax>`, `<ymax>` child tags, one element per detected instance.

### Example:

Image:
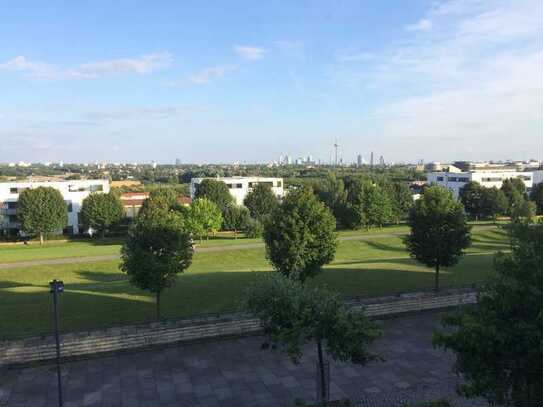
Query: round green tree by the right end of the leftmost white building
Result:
<box><xmin>81</xmin><ymin>193</ymin><xmax>124</xmax><ymax>236</ymax></box>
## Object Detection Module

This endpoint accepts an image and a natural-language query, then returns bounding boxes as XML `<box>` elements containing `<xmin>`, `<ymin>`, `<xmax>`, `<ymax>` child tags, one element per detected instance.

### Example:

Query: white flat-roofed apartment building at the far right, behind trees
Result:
<box><xmin>427</xmin><ymin>170</ymin><xmax>534</xmax><ymax>198</ymax></box>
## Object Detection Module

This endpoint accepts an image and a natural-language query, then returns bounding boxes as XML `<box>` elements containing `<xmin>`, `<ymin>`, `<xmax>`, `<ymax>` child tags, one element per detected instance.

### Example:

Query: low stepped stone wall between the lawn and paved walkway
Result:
<box><xmin>0</xmin><ymin>290</ymin><xmax>476</xmax><ymax>367</ymax></box>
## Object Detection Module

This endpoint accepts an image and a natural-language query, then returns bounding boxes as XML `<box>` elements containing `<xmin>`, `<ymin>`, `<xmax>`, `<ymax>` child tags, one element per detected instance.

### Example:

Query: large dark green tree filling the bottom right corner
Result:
<box><xmin>434</xmin><ymin>224</ymin><xmax>543</xmax><ymax>407</ymax></box>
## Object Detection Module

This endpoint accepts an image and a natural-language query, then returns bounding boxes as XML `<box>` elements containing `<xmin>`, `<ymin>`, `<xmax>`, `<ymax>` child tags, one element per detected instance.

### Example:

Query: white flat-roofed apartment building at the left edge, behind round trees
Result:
<box><xmin>0</xmin><ymin>179</ymin><xmax>109</xmax><ymax>234</ymax></box>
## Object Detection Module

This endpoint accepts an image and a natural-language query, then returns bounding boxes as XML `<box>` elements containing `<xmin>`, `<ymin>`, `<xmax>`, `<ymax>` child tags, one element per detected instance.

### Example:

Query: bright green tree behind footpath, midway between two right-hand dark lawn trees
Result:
<box><xmin>347</xmin><ymin>179</ymin><xmax>393</xmax><ymax>229</ymax></box>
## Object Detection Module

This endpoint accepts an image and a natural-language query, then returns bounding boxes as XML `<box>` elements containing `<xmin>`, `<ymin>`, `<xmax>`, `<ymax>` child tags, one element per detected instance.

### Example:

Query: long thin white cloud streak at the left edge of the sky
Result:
<box><xmin>0</xmin><ymin>52</ymin><xmax>173</xmax><ymax>80</ymax></box>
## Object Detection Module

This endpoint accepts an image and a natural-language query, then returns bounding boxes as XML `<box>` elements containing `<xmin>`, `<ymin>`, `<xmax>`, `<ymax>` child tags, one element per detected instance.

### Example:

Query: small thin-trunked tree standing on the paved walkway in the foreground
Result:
<box><xmin>243</xmin><ymin>274</ymin><xmax>380</xmax><ymax>402</ymax></box>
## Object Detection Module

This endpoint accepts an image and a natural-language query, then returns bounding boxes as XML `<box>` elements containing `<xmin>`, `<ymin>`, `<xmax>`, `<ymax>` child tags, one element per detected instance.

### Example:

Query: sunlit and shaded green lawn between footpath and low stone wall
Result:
<box><xmin>0</xmin><ymin>229</ymin><xmax>508</xmax><ymax>338</ymax></box>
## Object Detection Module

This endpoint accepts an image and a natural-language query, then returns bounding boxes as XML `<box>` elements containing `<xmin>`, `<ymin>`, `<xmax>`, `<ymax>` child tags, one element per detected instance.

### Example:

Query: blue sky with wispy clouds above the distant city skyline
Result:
<box><xmin>0</xmin><ymin>0</ymin><xmax>543</xmax><ymax>163</ymax></box>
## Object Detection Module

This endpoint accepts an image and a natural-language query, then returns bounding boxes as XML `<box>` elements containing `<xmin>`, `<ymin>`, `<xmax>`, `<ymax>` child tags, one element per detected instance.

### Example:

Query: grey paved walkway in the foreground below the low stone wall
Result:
<box><xmin>0</xmin><ymin>313</ymin><xmax>479</xmax><ymax>407</ymax></box>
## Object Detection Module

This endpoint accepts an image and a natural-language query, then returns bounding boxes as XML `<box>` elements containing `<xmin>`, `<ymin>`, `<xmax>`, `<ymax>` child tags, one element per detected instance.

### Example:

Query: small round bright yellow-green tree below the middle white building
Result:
<box><xmin>185</xmin><ymin>198</ymin><xmax>223</xmax><ymax>241</ymax></box>
